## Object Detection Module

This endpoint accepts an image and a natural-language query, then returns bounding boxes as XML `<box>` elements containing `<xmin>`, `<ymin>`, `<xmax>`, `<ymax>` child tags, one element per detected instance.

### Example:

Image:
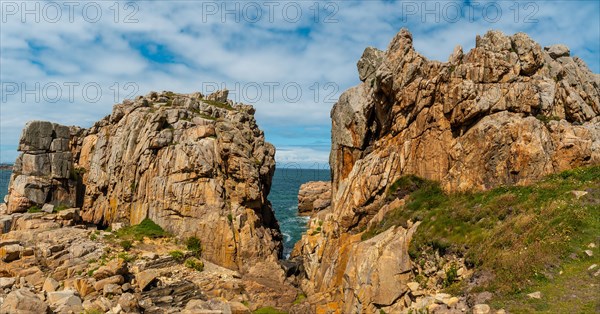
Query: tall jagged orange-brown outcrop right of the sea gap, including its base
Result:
<box><xmin>292</xmin><ymin>30</ymin><xmax>600</xmax><ymax>313</ymax></box>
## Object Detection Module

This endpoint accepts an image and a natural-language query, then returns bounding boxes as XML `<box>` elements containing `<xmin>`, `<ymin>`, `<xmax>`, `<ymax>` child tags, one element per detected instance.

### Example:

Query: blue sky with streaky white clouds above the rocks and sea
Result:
<box><xmin>0</xmin><ymin>0</ymin><xmax>600</xmax><ymax>168</ymax></box>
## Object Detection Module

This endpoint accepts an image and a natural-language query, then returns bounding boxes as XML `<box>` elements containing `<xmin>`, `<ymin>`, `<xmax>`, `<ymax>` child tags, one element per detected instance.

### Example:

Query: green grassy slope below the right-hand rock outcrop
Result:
<box><xmin>362</xmin><ymin>166</ymin><xmax>600</xmax><ymax>295</ymax></box>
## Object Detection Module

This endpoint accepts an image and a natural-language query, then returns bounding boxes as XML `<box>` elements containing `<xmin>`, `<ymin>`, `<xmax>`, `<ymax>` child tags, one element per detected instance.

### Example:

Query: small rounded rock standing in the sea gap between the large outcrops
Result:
<box><xmin>298</xmin><ymin>181</ymin><xmax>331</xmax><ymax>214</ymax></box>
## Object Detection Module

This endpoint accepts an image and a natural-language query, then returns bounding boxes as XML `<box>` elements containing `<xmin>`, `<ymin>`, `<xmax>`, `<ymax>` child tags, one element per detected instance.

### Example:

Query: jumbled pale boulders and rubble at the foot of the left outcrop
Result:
<box><xmin>0</xmin><ymin>206</ymin><xmax>298</xmax><ymax>313</ymax></box>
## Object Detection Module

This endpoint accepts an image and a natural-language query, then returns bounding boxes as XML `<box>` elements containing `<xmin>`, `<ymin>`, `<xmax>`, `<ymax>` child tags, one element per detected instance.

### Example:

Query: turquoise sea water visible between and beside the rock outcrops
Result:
<box><xmin>0</xmin><ymin>168</ymin><xmax>330</xmax><ymax>256</ymax></box>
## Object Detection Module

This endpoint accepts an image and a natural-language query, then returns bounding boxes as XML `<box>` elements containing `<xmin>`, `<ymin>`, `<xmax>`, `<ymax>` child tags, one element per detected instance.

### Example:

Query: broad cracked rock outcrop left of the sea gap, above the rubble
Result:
<box><xmin>7</xmin><ymin>91</ymin><xmax>282</xmax><ymax>269</ymax></box>
